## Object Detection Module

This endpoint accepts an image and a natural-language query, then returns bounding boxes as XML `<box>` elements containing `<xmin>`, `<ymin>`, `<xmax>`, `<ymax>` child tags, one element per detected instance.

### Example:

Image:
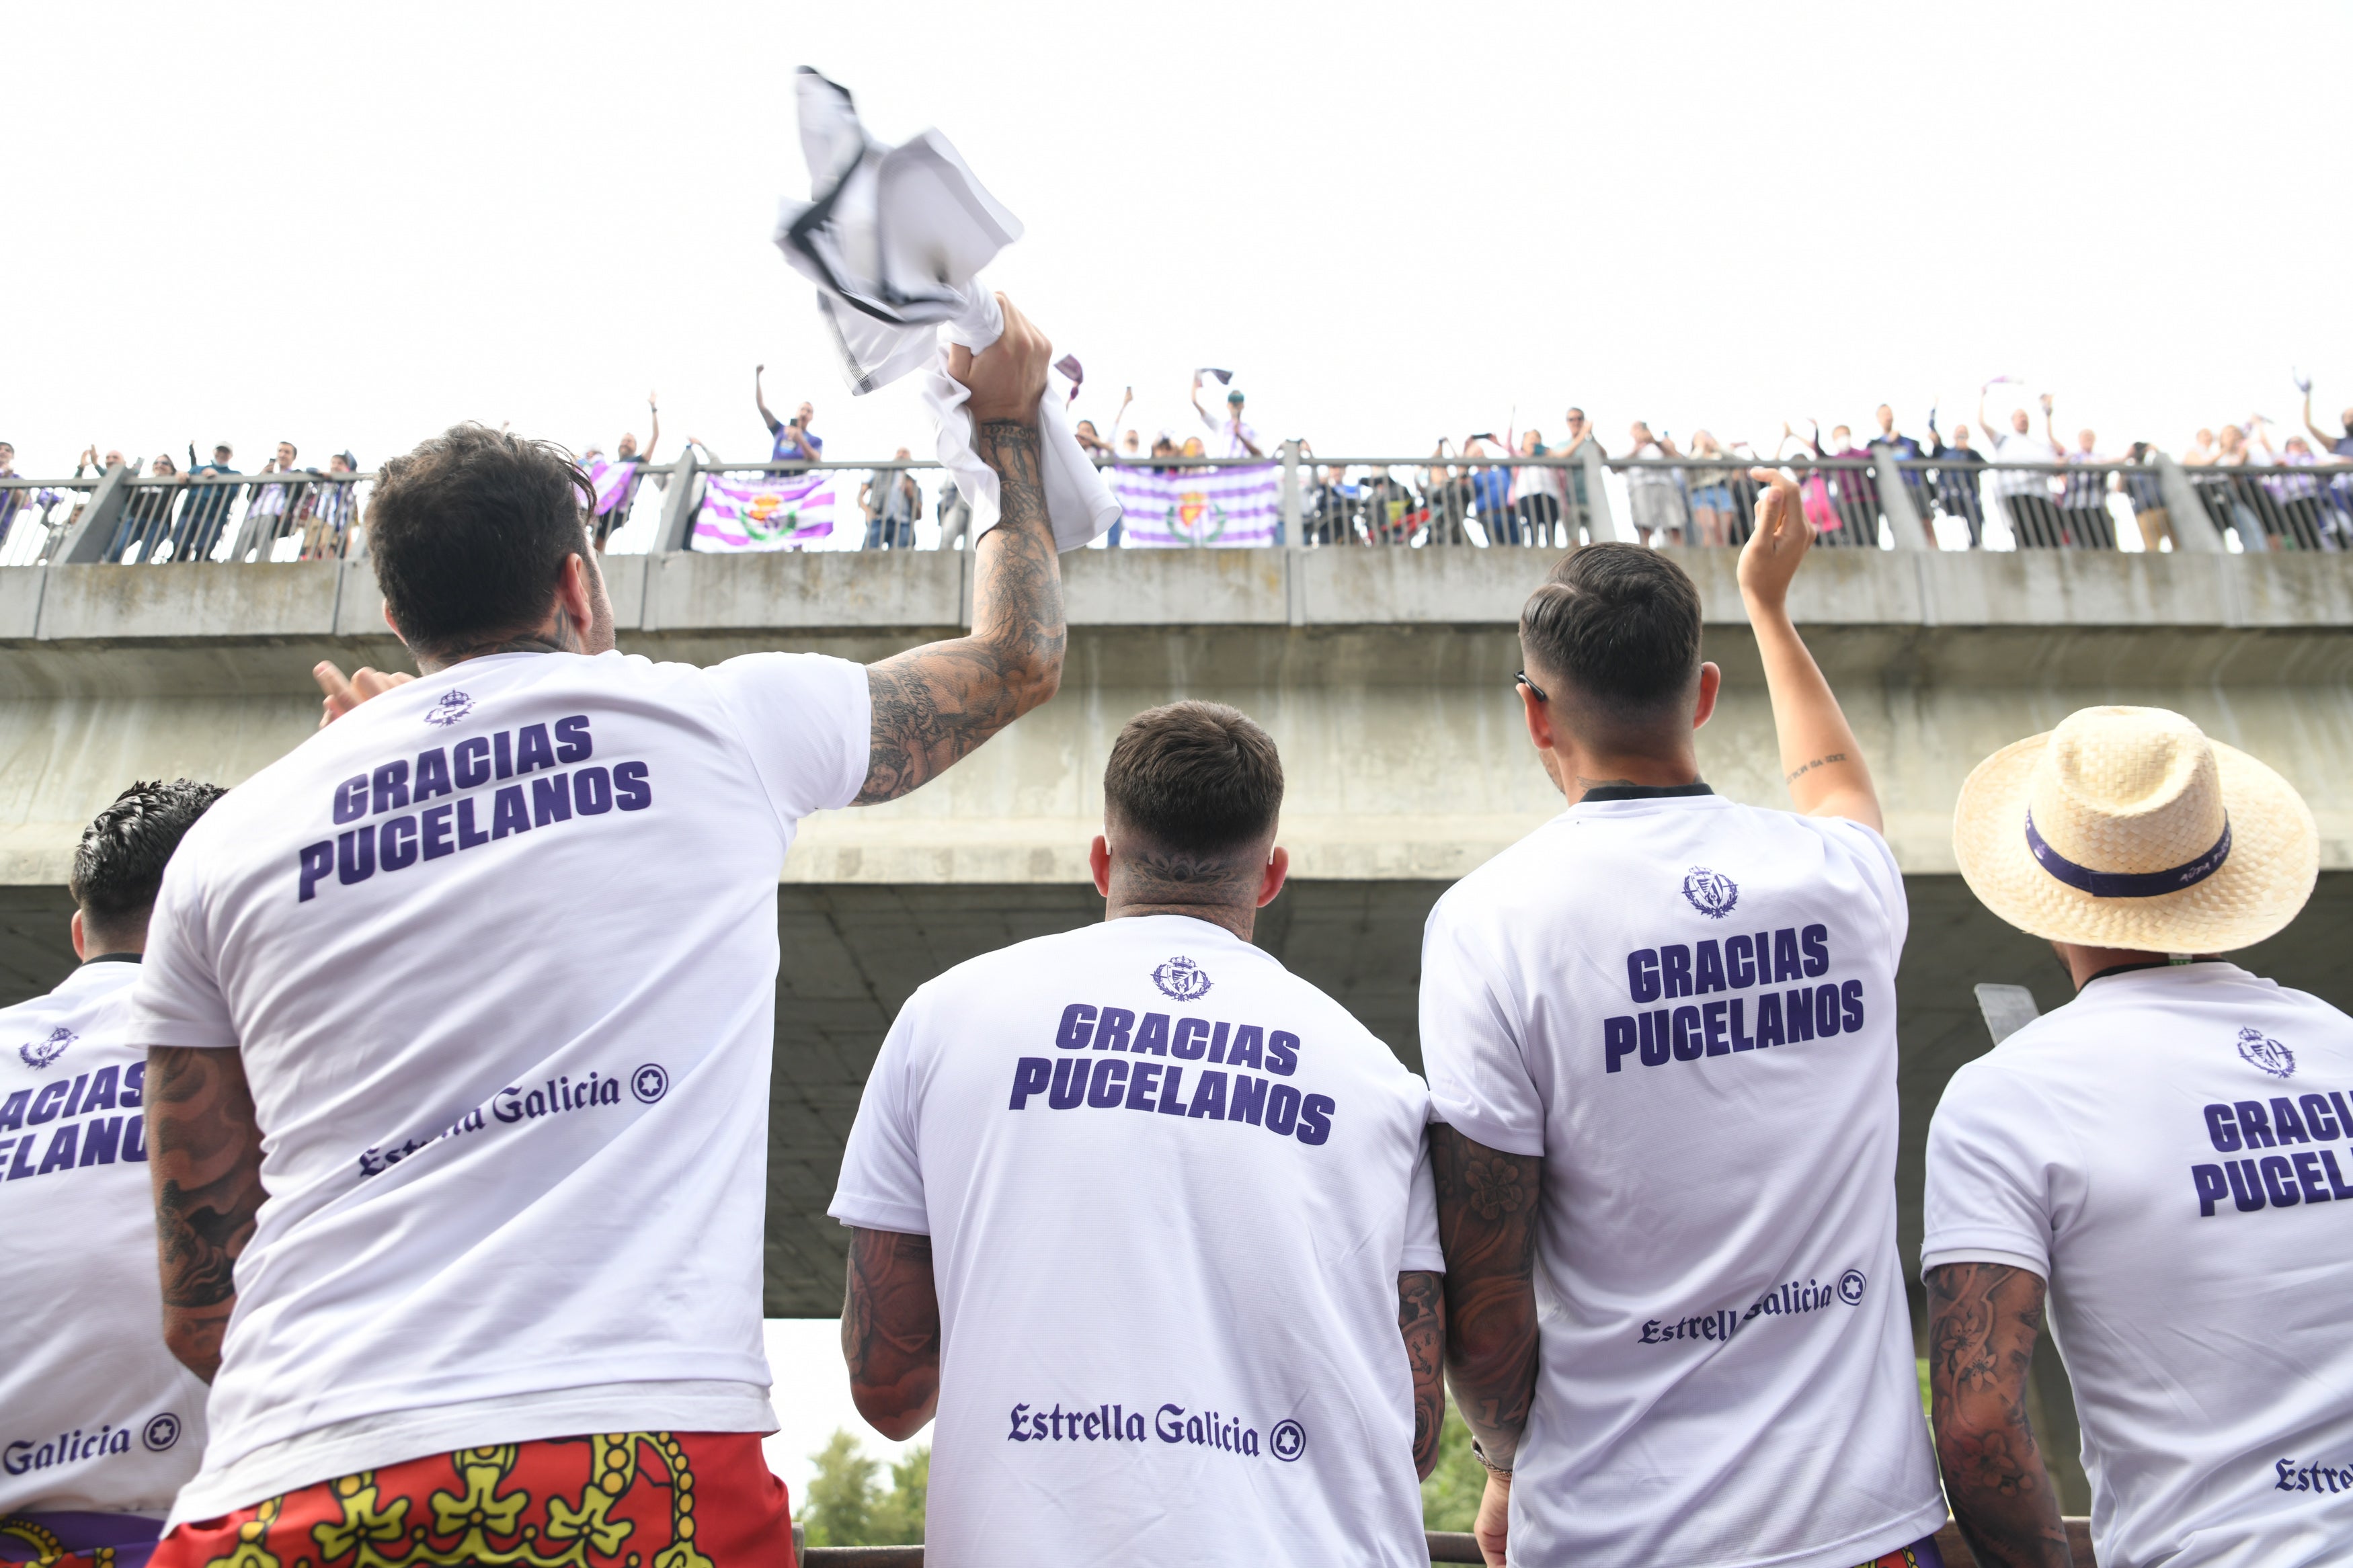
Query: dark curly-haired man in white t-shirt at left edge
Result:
<box><xmin>0</xmin><ymin>778</ymin><xmax>221</xmax><ymax>1568</ymax></box>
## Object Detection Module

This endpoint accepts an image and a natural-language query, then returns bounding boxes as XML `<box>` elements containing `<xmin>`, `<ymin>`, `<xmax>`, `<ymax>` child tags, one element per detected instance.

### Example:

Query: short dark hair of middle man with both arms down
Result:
<box><xmin>1104</xmin><ymin>703</ymin><xmax>1283</xmax><ymax>856</ymax></box>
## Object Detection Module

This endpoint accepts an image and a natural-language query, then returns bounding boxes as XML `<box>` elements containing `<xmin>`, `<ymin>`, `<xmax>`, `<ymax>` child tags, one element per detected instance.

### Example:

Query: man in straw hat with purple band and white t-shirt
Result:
<box><xmin>1920</xmin><ymin>708</ymin><xmax>2353</xmax><ymax>1568</ymax></box>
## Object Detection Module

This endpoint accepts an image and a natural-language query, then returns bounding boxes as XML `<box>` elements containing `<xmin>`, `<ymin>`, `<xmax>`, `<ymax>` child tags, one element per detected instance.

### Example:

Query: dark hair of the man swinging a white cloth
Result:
<box><xmin>367</xmin><ymin>423</ymin><xmax>596</xmax><ymax>653</ymax></box>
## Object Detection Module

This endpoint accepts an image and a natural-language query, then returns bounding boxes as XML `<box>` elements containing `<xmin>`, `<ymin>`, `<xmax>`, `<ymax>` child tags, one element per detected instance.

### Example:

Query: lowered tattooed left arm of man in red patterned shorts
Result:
<box><xmin>146</xmin><ymin>1046</ymin><xmax>266</xmax><ymax>1383</ymax></box>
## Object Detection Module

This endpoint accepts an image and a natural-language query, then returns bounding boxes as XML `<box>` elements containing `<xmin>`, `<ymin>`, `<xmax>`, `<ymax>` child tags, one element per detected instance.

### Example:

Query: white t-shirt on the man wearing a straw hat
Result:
<box><xmin>1920</xmin><ymin>964</ymin><xmax>2353</xmax><ymax>1568</ymax></box>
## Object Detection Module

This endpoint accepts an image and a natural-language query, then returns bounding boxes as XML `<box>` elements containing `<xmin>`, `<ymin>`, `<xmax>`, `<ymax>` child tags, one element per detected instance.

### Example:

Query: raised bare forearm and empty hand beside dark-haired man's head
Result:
<box><xmin>1741</xmin><ymin>468</ymin><xmax>1882</xmax><ymax>830</ymax></box>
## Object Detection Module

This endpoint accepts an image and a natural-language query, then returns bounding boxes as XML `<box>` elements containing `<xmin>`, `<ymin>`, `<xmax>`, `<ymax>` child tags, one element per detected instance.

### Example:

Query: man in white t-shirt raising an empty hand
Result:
<box><xmin>1421</xmin><ymin>468</ymin><xmax>1944</xmax><ymax>1568</ymax></box>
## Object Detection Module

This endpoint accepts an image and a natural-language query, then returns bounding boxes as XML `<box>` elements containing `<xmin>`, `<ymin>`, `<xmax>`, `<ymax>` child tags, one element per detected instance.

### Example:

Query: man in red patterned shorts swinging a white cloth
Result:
<box><xmin>130</xmin><ymin>297</ymin><xmax>1064</xmax><ymax>1568</ymax></box>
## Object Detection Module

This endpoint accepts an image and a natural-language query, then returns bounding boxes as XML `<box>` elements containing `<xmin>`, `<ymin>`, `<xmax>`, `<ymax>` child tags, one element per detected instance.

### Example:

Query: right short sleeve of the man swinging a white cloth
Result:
<box><xmin>706</xmin><ymin>653</ymin><xmax>873</xmax><ymax>827</ymax></box>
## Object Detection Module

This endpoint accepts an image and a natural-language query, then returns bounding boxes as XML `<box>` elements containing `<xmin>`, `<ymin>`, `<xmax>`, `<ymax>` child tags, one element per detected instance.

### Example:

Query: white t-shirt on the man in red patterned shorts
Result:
<box><xmin>127</xmin><ymin>653</ymin><xmax>871</xmax><ymax>1519</ymax></box>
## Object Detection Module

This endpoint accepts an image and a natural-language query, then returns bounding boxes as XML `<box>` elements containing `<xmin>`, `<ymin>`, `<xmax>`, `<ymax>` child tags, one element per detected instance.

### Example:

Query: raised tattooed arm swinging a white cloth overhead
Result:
<box><xmin>856</xmin><ymin>296</ymin><xmax>1066</xmax><ymax>807</ymax></box>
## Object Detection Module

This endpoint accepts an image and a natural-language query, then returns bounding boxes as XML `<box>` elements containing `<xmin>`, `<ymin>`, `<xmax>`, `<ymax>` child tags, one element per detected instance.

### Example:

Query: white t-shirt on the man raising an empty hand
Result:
<box><xmin>1421</xmin><ymin>792</ymin><xmax>1944</xmax><ymax>1568</ymax></box>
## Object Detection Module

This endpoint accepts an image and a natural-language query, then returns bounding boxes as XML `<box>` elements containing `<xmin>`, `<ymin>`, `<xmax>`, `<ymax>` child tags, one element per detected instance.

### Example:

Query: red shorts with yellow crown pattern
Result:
<box><xmin>153</xmin><ymin>1432</ymin><xmax>793</xmax><ymax>1568</ymax></box>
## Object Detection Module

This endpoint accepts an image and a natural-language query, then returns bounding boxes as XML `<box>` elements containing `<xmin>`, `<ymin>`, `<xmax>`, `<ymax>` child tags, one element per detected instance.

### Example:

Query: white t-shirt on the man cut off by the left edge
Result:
<box><xmin>0</xmin><ymin>959</ymin><xmax>205</xmax><ymax>1516</ymax></box>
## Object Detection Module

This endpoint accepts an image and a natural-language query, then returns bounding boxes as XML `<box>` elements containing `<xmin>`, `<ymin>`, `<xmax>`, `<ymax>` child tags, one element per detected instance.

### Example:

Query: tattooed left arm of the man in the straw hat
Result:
<box><xmin>1927</xmin><ymin>1262</ymin><xmax>2073</xmax><ymax>1568</ymax></box>
